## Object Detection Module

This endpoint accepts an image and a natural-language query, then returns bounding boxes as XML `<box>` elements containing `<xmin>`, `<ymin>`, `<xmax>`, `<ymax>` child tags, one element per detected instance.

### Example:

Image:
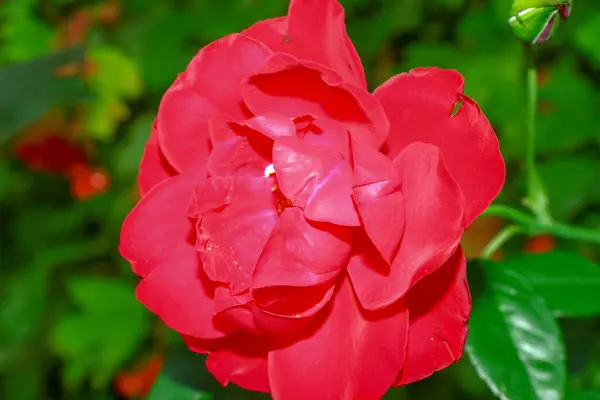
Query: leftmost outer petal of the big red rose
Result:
<box><xmin>119</xmin><ymin>174</ymin><xmax>199</xmax><ymax>276</ymax></box>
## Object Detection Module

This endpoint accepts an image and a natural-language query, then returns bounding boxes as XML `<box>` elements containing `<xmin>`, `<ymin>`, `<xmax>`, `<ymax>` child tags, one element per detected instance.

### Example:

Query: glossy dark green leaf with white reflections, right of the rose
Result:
<box><xmin>466</xmin><ymin>262</ymin><xmax>566</xmax><ymax>400</ymax></box>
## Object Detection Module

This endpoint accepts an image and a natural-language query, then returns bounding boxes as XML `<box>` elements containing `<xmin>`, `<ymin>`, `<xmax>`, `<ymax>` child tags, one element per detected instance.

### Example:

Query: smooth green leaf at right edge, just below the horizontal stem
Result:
<box><xmin>506</xmin><ymin>252</ymin><xmax>600</xmax><ymax>317</ymax></box>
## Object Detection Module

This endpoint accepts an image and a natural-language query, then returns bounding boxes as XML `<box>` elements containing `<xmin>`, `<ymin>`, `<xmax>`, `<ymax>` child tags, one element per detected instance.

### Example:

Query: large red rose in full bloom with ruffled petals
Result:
<box><xmin>120</xmin><ymin>0</ymin><xmax>504</xmax><ymax>400</ymax></box>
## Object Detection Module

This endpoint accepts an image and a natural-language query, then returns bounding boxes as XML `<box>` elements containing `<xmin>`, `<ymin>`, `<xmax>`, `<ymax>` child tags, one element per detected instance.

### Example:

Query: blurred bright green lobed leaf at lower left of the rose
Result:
<box><xmin>51</xmin><ymin>276</ymin><xmax>150</xmax><ymax>388</ymax></box>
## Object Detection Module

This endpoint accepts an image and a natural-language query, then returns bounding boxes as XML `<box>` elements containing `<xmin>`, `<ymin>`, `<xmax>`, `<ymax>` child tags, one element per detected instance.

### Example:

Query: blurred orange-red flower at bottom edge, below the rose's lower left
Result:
<box><xmin>114</xmin><ymin>355</ymin><xmax>164</xmax><ymax>399</ymax></box>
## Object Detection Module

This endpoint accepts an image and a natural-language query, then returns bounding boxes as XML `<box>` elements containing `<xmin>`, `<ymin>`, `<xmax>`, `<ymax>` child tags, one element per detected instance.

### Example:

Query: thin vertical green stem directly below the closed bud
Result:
<box><xmin>525</xmin><ymin>45</ymin><xmax>552</xmax><ymax>224</ymax></box>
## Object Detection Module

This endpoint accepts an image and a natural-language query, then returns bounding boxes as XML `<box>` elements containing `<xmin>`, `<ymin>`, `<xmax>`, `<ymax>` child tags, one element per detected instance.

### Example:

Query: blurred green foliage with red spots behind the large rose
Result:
<box><xmin>0</xmin><ymin>0</ymin><xmax>600</xmax><ymax>400</ymax></box>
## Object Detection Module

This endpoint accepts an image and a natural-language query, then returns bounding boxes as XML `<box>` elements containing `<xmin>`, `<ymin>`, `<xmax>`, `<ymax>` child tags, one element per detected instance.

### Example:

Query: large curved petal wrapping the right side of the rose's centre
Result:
<box><xmin>348</xmin><ymin>143</ymin><xmax>464</xmax><ymax>309</ymax></box>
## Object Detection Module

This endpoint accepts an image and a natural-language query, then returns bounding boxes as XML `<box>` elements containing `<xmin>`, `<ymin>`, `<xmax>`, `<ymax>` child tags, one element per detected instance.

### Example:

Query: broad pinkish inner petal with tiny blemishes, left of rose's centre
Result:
<box><xmin>196</xmin><ymin>178</ymin><xmax>278</xmax><ymax>294</ymax></box>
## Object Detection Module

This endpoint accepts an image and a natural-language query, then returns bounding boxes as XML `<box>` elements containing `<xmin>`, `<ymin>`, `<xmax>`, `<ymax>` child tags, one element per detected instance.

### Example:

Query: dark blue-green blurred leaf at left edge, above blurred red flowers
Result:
<box><xmin>0</xmin><ymin>48</ymin><xmax>87</xmax><ymax>143</ymax></box>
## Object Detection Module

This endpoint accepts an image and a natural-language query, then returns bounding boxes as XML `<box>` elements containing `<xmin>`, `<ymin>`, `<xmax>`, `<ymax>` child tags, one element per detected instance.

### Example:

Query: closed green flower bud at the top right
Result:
<box><xmin>508</xmin><ymin>0</ymin><xmax>572</xmax><ymax>44</ymax></box>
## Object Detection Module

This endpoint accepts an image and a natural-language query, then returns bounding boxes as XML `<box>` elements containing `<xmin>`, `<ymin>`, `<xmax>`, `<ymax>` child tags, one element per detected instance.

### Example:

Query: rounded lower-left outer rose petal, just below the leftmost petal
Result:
<box><xmin>136</xmin><ymin>256</ymin><xmax>237</xmax><ymax>339</ymax></box>
